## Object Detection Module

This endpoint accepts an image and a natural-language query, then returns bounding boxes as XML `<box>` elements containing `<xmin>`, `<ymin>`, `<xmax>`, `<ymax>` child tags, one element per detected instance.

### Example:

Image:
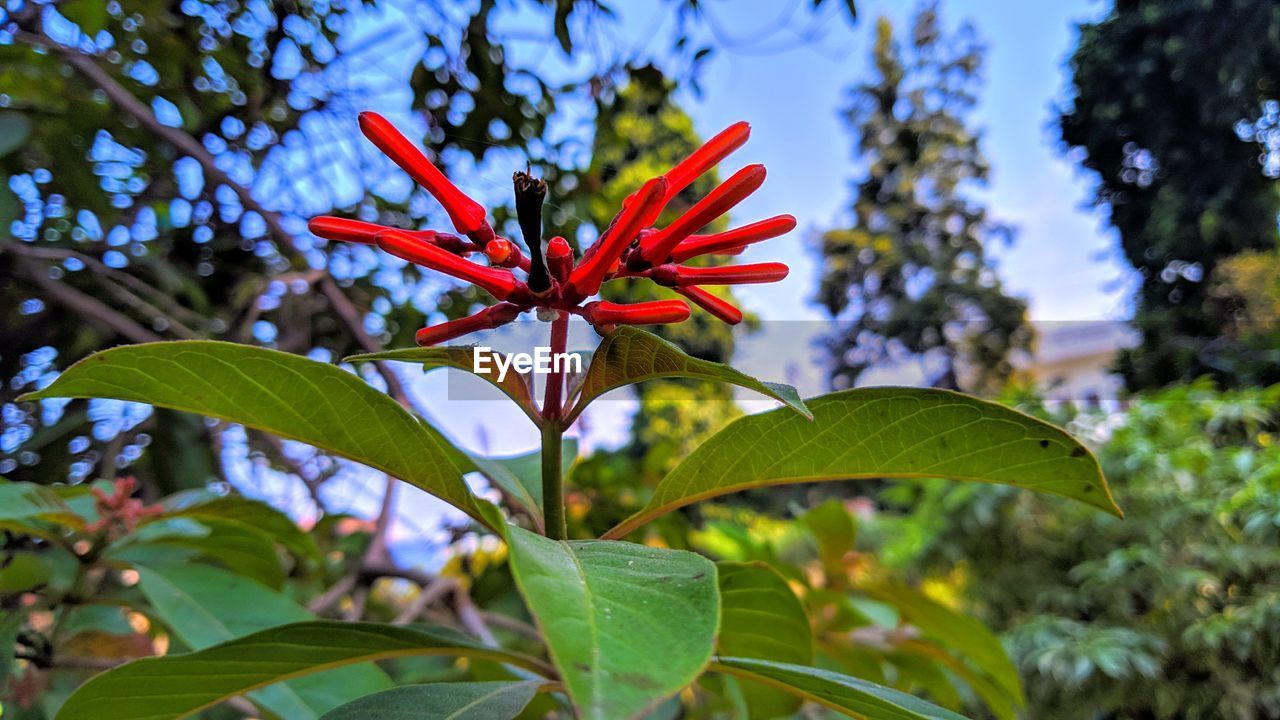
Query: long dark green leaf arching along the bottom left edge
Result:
<box><xmin>58</xmin><ymin>617</ymin><xmax>543</xmax><ymax>720</ymax></box>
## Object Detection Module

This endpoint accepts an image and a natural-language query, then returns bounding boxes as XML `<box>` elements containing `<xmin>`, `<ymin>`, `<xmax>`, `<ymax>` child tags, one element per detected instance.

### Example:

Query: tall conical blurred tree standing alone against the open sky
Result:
<box><xmin>818</xmin><ymin>4</ymin><xmax>1029</xmax><ymax>391</ymax></box>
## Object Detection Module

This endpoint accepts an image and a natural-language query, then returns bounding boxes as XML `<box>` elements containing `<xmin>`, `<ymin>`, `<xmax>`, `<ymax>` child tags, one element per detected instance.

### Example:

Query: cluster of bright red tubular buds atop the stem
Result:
<box><xmin>310</xmin><ymin>113</ymin><xmax>796</xmax><ymax>346</ymax></box>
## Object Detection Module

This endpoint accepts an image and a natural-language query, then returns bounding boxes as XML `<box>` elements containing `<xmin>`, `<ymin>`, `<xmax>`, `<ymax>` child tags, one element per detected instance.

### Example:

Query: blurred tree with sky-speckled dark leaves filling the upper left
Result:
<box><xmin>0</xmin><ymin>0</ymin><xmax>851</xmax><ymax>500</ymax></box>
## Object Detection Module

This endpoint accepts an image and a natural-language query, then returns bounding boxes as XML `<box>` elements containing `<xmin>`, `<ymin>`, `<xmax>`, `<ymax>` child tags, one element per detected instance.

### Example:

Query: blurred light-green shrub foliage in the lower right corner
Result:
<box><xmin>884</xmin><ymin>380</ymin><xmax>1280</xmax><ymax>719</ymax></box>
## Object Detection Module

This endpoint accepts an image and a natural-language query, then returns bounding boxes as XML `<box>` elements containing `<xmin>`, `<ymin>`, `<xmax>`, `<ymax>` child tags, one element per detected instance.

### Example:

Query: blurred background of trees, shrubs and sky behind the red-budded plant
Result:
<box><xmin>0</xmin><ymin>0</ymin><xmax>1280</xmax><ymax>719</ymax></box>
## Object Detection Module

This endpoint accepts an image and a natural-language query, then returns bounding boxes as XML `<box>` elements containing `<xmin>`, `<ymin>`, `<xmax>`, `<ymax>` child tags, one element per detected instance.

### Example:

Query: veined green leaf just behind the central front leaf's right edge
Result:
<box><xmin>716</xmin><ymin>562</ymin><xmax>813</xmax><ymax>719</ymax></box>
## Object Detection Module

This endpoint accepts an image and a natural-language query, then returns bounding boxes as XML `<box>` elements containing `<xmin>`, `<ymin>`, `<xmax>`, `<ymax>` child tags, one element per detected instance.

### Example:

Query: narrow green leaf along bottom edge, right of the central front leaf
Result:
<box><xmin>710</xmin><ymin>657</ymin><xmax>965</xmax><ymax>720</ymax></box>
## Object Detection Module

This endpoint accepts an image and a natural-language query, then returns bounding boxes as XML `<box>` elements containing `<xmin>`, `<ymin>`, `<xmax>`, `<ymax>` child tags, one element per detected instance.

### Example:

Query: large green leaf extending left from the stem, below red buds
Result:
<box><xmin>22</xmin><ymin>341</ymin><xmax>484</xmax><ymax>530</ymax></box>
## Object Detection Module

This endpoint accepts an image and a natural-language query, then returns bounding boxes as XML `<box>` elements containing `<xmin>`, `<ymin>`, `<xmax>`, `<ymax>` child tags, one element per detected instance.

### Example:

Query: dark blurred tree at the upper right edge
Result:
<box><xmin>1061</xmin><ymin>0</ymin><xmax>1280</xmax><ymax>388</ymax></box>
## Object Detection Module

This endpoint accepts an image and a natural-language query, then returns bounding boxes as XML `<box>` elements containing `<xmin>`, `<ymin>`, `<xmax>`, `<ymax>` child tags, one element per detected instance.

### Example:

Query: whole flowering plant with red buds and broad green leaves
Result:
<box><xmin>20</xmin><ymin>114</ymin><xmax>1119</xmax><ymax>720</ymax></box>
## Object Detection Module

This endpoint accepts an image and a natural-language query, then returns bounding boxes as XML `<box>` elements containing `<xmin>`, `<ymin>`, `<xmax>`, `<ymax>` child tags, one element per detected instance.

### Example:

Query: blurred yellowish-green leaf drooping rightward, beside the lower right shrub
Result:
<box><xmin>858</xmin><ymin>583</ymin><xmax>1023</xmax><ymax>706</ymax></box>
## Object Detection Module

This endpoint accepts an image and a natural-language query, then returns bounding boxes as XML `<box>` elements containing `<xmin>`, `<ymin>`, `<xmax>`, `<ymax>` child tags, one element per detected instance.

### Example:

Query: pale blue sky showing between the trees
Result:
<box><xmin>267</xmin><ymin>0</ymin><xmax>1128</xmax><ymax>556</ymax></box>
